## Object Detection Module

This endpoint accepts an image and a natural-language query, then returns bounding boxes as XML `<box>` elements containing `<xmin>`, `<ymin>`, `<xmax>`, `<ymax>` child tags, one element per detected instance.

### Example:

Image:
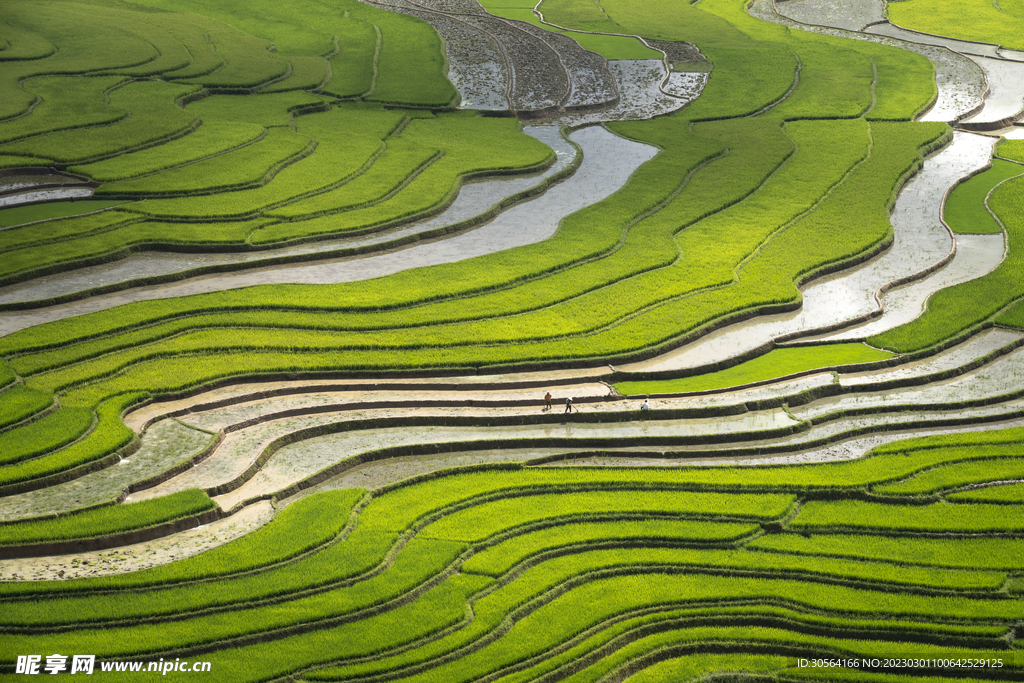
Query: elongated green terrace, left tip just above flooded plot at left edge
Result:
<box><xmin>68</xmin><ymin>121</ymin><xmax>265</xmax><ymax>182</ymax></box>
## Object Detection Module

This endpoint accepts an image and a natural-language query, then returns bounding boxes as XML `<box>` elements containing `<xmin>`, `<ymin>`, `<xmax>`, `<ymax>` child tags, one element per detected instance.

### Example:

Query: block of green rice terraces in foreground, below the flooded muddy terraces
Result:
<box><xmin>0</xmin><ymin>429</ymin><xmax>1024</xmax><ymax>681</ymax></box>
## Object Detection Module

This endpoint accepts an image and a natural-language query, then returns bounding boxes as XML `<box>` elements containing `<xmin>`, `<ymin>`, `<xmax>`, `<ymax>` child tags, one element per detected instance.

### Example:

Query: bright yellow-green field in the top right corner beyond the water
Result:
<box><xmin>889</xmin><ymin>0</ymin><xmax>1024</xmax><ymax>49</ymax></box>
